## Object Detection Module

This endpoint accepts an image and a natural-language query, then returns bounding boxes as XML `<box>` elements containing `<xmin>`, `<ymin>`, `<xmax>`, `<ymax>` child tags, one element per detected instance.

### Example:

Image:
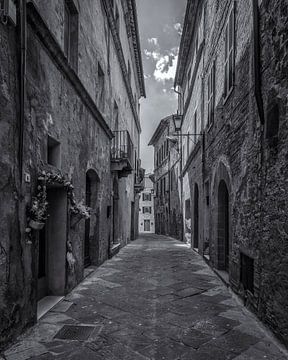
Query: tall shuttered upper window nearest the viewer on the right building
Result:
<box><xmin>224</xmin><ymin>7</ymin><xmax>235</xmax><ymax>98</ymax></box>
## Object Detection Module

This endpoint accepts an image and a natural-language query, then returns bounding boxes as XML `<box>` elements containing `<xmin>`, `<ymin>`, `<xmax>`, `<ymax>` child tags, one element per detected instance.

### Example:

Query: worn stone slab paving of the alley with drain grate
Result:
<box><xmin>0</xmin><ymin>235</ymin><xmax>288</xmax><ymax>360</ymax></box>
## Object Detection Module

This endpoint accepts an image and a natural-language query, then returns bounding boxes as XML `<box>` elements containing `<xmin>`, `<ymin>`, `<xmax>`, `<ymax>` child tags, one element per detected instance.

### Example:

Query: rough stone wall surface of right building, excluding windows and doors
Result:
<box><xmin>178</xmin><ymin>0</ymin><xmax>288</xmax><ymax>344</ymax></box>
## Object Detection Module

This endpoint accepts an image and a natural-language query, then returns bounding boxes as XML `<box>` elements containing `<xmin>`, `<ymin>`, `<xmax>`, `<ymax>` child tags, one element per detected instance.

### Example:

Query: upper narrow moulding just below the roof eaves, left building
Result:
<box><xmin>101</xmin><ymin>0</ymin><xmax>141</xmax><ymax>132</ymax></box>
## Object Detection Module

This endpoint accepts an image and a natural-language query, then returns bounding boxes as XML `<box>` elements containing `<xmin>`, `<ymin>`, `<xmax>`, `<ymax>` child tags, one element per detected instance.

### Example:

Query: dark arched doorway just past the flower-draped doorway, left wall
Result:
<box><xmin>84</xmin><ymin>169</ymin><xmax>99</xmax><ymax>267</ymax></box>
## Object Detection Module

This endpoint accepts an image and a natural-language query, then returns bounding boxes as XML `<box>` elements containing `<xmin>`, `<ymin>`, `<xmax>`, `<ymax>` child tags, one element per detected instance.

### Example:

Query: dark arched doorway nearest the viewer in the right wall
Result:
<box><xmin>217</xmin><ymin>180</ymin><xmax>230</xmax><ymax>271</ymax></box>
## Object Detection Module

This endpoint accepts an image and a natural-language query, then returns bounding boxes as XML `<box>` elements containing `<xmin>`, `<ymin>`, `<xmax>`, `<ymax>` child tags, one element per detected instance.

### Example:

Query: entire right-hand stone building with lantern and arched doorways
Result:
<box><xmin>175</xmin><ymin>0</ymin><xmax>288</xmax><ymax>345</ymax></box>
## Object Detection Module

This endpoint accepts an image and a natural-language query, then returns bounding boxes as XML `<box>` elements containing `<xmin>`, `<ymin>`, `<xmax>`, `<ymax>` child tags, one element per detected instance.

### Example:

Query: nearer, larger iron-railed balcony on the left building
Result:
<box><xmin>111</xmin><ymin>130</ymin><xmax>134</xmax><ymax>178</ymax></box>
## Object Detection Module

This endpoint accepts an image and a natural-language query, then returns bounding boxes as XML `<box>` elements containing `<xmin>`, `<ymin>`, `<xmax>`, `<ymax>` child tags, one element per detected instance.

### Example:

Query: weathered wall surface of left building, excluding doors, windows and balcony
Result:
<box><xmin>0</xmin><ymin>0</ymin><xmax>141</xmax><ymax>347</ymax></box>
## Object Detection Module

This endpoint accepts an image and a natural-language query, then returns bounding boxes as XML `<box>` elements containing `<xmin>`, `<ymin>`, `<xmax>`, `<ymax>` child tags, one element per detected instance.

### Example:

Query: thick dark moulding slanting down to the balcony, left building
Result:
<box><xmin>27</xmin><ymin>1</ymin><xmax>114</xmax><ymax>139</ymax></box>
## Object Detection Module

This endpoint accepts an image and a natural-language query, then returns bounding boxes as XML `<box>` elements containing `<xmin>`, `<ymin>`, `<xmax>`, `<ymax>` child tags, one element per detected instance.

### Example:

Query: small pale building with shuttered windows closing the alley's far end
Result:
<box><xmin>139</xmin><ymin>174</ymin><xmax>155</xmax><ymax>233</ymax></box>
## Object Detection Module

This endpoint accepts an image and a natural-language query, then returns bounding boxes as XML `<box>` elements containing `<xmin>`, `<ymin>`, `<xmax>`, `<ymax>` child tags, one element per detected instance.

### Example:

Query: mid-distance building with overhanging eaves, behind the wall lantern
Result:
<box><xmin>149</xmin><ymin>116</ymin><xmax>182</xmax><ymax>239</ymax></box>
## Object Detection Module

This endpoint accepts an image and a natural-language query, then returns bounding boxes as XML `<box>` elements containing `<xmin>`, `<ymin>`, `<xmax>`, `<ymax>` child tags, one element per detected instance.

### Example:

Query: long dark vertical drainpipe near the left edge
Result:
<box><xmin>18</xmin><ymin>0</ymin><xmax>26</xmax><ymax>188</ymax></box>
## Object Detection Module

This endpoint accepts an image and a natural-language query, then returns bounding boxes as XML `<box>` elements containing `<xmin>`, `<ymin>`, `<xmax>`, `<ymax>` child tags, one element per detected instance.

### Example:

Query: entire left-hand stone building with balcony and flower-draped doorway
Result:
<box><xmin>0</xmin><ymin>0</ymin><xmax>145</xmax><ymax>347</ymax></box>
